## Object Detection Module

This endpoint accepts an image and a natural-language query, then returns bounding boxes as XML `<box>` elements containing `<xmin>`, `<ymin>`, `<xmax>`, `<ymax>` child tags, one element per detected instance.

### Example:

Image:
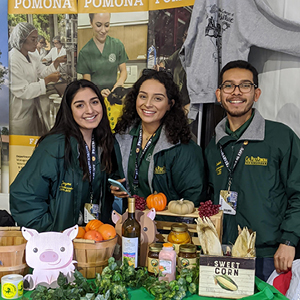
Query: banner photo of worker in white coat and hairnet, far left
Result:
<box><xmin>8</xmin><ymin>14</ymin><xmax>77</xmax><ymax>136</ymax></box>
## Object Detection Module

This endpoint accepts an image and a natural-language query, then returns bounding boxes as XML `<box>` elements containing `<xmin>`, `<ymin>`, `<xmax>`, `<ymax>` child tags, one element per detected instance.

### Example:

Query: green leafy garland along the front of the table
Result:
<box><xmin>22</xmin><ymin>257</ymin><xmax>199</xmax><ymax>300</ymax></box>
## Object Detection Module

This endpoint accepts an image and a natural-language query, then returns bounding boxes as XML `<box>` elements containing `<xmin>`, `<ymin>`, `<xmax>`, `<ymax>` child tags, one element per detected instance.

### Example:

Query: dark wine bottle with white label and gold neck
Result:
<box><xmin>122</xmin><ymin>197</ymin><xmax>141</xmax><ymax>268</ymax></box>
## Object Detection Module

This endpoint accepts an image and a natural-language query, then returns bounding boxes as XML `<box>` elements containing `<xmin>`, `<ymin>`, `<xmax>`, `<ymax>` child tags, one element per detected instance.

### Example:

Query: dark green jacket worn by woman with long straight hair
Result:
<box><xmin>10</xmin><ymin>135</ymin><xmax>113</xmax><ymax>232</ymax></box>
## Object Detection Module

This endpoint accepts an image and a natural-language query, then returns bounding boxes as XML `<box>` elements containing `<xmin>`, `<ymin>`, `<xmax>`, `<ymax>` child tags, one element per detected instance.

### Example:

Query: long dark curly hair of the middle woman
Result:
<box><xmin>115</xmin><ymin>69</ymin><xmax>191</xmax><ymax>144</ymax></box>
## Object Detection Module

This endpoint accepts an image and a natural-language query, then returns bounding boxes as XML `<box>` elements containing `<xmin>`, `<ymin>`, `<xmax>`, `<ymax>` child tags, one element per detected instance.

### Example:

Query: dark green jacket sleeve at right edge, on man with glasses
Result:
<box><xmin>280</xmin><ymin>131</ymin><xmax>300</xmax><ymax>245</ymax></box>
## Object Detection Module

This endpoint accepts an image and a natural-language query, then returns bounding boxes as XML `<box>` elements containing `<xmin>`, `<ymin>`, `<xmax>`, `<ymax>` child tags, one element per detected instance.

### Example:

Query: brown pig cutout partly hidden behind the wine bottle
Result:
<box><xmin>111</xmin><ymin>208</ymin><xmax>157</xmax><ymax>266</ymax></box>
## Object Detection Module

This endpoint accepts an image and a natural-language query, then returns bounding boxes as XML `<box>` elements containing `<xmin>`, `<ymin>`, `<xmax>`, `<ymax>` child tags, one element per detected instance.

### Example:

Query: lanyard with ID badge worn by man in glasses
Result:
<box><xmin>219</xmin><ymin>141</ymin><xmax>248</xmax><ymax>215</ymax></box>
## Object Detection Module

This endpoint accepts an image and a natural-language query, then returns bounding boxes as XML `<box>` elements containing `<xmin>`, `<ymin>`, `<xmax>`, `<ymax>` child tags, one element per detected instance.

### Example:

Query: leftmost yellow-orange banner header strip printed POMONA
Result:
<box><xmin>8</xmin><ymin>0</ymin><xmax>77</xmax><ymax>14</ymax></box>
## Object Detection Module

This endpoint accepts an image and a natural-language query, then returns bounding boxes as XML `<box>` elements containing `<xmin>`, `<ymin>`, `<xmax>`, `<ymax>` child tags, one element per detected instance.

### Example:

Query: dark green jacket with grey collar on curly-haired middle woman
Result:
<box><xmin>115</xmin><ymin>127</ymin><xmax>206</xmax><ymax>206</ymax></box>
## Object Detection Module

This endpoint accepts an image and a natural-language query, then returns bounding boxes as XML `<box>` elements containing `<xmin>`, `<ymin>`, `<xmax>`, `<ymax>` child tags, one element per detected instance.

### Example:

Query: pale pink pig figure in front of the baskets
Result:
<box><xmin>22</xmin><ymin>225</ymin><xmax>78</xmax><ymax>290</ymax></box>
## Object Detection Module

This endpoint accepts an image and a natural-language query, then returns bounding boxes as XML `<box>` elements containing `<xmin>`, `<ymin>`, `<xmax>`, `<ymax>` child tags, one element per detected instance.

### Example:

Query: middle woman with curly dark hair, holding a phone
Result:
<box><xmin>111</xmin><ymin>69</ymin><xmax>205</xmax><ymax>206</ymax></box>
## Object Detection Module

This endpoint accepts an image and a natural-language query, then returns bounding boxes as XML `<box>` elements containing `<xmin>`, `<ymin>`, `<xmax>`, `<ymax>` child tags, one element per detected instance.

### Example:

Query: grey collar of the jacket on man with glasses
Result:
<box><xmin>216</xmin><ymin>108</ymin><xmax>265</xmax><ymax>144</ymax></box>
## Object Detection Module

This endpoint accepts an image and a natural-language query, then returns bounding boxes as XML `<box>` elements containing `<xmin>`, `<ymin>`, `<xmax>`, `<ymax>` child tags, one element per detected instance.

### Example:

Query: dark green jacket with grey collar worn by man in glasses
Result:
<box><xmin>205</xmin><ymin>110</ymin><xmax>300</xmax><ymax>257</ymax></box>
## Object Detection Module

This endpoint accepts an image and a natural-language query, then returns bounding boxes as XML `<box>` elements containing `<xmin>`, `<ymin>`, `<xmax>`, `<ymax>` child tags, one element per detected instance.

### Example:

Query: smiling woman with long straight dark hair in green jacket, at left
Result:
<box><xmin>10</xmin><ymin>79</ymin><xmax>117</xmax><ymax>232</ymax></box>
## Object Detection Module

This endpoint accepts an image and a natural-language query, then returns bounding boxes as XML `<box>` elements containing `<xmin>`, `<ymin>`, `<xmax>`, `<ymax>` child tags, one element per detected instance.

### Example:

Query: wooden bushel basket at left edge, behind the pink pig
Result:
<box><xmin>0</xmin><ymin>227</ymin><xmax>29</xmax><ymax>280</ymax></box>
